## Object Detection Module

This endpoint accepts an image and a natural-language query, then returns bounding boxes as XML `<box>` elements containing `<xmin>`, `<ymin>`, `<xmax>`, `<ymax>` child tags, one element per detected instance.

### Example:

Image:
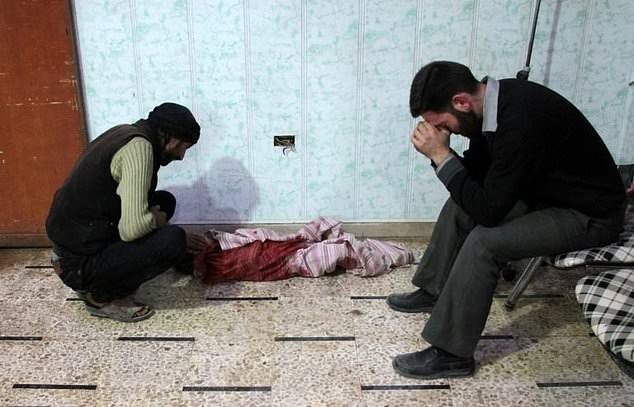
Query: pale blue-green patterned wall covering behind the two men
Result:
<box><xmin>74</xmin><ymin>0</ymin><xmax>634</xmax><ymax>223</ymax></box>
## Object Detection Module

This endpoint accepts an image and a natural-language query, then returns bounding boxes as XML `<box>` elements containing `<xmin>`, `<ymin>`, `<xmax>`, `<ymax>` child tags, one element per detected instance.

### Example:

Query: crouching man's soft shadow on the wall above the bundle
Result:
<box><xmin>167</xmin><ymin>157</ymin><xmax>259</xmax><ymax>224</ymax></box>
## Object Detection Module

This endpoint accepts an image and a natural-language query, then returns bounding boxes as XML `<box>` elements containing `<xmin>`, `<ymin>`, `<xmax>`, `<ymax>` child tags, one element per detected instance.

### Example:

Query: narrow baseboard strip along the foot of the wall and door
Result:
<box><xmin>0</xmin><ymin>222</ymin><xmax>434</xmax><ymax>248</ymax></box>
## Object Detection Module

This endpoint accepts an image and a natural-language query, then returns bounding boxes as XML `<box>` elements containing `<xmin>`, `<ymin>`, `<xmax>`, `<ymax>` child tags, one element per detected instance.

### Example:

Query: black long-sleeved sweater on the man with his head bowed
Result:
<box><xmin>438</xmin><ymin>79</ymin><xmax>625</xmax><ymax>226</ymax></box>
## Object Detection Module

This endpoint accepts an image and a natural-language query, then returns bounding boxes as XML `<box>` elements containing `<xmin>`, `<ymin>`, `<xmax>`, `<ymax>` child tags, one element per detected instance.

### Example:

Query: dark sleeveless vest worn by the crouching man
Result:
<box><xmin>46</xmin><ymin>120</ymin><xmax>160</xmax><ymax>256</ymax></box>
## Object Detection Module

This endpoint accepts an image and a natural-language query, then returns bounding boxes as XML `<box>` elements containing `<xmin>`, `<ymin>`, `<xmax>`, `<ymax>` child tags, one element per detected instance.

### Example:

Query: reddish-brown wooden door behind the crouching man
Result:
<box><xmin>0</xmin><ymin>0</ymin><xmax>86</xmax><ymax>246</ymax></box>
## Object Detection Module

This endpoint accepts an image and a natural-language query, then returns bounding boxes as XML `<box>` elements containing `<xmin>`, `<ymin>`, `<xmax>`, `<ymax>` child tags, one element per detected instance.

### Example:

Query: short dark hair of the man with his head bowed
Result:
<box><xmin>409</xmin><ymin>61</ymin><xmax>478</xmax><ymax>117</ymax></box>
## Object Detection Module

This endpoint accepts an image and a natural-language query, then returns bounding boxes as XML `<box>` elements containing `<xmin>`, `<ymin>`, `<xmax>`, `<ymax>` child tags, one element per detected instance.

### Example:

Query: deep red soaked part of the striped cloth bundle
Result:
<box><xmin>194</xmin><ymin>239</ymin><xmax>308</xmax><ymax>284</ymax></box>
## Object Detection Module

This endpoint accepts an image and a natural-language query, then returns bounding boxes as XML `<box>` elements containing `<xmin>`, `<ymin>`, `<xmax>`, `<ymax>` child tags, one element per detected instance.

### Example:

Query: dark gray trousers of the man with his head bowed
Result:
<box><xmin>412</xmin><ymin>198</ymin><xmax>623</xmax><ymax>357</ymax></box>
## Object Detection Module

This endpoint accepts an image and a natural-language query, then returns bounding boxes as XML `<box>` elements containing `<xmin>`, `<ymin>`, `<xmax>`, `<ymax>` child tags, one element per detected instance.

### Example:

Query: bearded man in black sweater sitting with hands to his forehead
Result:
<box><xmin>387</xmin><ymin>61</ymin><xmax>625</xmax><ymax>379</ymax></box>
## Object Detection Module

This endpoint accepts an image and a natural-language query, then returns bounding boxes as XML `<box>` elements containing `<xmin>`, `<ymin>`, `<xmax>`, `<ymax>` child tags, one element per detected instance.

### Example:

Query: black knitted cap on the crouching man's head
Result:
<box><xmin>148</xmin><ymin>102</ymin><xmax>200</xmax><ymax>144</ymax></box>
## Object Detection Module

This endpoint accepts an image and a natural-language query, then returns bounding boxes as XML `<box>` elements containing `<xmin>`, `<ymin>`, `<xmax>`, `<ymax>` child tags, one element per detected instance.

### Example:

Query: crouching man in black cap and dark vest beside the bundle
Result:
<box><xmin>46</xmin><ymin>103</ymin><xmax>204</xmax><ymax>322</ymax></box>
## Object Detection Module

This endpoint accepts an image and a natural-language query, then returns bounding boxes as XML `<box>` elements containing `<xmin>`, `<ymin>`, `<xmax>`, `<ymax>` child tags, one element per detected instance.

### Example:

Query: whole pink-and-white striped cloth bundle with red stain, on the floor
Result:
<box><xmin>194</xmin><ymin>217</ymin><xmax>414</xmax><ymax>283</ymax></box>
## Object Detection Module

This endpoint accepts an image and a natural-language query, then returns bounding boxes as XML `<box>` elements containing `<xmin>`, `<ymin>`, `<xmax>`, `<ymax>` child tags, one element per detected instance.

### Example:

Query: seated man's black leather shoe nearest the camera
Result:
<box><xmin>392</xmin><ymin>346</ymin><xmax>475</xmax><ymax>379</ymax></box>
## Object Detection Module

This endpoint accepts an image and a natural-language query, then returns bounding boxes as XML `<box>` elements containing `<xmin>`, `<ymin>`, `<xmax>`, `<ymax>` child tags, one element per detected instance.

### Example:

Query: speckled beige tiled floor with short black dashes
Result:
<box><xmin>0</xmin><ymin>241</ymin><xmax>634</xmax><ymax>407</ymax></box>
